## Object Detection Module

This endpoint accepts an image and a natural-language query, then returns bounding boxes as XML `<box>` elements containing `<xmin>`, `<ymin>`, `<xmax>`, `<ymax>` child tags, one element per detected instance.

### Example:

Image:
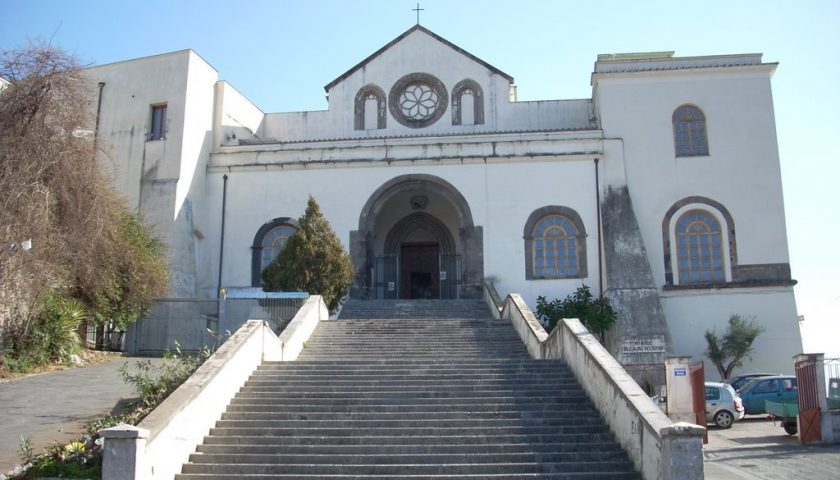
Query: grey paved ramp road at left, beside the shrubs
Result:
<box><xmin>0</xmin><ymin>358</ymin><xmax>153</xmax><ymax>473</ymax></box>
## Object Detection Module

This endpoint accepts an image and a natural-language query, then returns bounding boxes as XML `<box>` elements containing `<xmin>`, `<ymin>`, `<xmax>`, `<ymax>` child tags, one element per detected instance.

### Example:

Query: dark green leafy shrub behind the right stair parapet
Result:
<box><xmin>537</xmin><ymin>285</ymin><xmax>616</xmax><ymax>343</ymax></box>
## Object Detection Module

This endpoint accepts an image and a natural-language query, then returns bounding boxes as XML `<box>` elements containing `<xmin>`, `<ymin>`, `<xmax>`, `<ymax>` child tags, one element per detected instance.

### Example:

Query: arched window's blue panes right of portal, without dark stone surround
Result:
<box><xmin>533</xmin><ymin>215</ymin><xmax>578</xmax><ymax>278</ymax></box>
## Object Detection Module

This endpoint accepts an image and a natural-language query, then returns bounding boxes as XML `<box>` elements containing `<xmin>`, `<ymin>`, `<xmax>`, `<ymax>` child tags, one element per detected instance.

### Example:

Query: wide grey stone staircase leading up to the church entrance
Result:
<box><xmin>176</xmin><ymin>301</ymin><xmax>641</xmax><ymax>480</ymax></box>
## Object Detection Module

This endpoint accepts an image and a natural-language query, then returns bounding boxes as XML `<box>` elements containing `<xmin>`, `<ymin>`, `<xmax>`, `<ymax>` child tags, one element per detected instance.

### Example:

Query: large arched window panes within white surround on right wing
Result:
<box><xmin>675</xmin><ymin>210</ymin><xmax>725</xmax><ymax>284</ymax></box>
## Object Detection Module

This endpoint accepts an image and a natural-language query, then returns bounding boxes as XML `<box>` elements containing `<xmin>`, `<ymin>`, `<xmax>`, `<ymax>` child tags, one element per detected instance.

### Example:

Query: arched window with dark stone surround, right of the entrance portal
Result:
<box><xmin>524</xmin><ymin>206</ymin><xmax>587</xmax><ymax>280</ymax></box>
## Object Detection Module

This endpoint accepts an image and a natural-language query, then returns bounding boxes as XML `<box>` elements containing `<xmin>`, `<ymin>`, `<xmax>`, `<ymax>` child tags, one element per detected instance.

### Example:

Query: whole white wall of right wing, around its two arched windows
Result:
<box><xmin>596</xmin><ymin>65</ymin><xmax>802</xmax><ymax>372</ymax></box>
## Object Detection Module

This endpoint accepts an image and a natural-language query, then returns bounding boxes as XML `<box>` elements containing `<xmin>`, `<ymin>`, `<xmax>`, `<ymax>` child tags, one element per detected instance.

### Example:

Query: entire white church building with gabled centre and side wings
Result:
<box><xmin>87</xmin><ymin>25</ymin><xmax>802</xmax><ymax>378</ymax></box>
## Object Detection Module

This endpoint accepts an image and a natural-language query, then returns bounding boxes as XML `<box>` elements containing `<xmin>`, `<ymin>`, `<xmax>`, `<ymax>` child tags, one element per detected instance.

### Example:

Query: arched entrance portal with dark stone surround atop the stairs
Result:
<box><xmin>350</xmin><ymin>175</ymin><xmax>484</xmax><ymax>298</ymax></box>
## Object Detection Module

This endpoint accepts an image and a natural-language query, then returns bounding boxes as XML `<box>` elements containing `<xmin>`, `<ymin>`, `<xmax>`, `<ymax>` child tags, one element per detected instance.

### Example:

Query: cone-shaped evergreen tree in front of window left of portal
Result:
<box><xmin>262</xmin><ymin>196</ymin><xmax>355</xmax><ymax>311</ymax></box>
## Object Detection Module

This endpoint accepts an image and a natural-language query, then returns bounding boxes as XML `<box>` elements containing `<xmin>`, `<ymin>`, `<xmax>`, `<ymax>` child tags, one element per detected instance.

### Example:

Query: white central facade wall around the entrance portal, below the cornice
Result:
<box><xmin>205</xmin><ymin>157</ymin><xmax>598</xmax><ymax>306</ymax></box>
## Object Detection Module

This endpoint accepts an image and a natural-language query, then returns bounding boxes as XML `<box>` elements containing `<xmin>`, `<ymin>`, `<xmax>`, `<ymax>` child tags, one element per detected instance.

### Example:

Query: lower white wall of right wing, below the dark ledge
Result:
<box><xmin>662</xmin><ymin>287</ymin><xmax>802</xmax><ymax>381</ymax></box>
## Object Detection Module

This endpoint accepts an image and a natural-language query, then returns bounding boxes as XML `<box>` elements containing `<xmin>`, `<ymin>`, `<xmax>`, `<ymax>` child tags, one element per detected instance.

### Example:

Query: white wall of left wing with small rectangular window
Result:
<box><xmin>87</xmin><ymin>50</ymin><xmax>218</xmax><ymax>296</ymax></box>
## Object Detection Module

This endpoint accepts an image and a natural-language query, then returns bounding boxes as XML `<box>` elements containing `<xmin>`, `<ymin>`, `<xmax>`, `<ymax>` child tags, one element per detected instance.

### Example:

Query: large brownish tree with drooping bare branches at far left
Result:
<box><xmin>0</xmin><ymin>44</ymin><xmax>168</xmax><ymax>357</ymax></box>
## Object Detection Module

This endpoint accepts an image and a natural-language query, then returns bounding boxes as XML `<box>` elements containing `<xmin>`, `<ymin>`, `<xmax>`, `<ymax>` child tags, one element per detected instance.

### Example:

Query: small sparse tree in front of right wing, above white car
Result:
<box><xmin>705</xmin><ymin>314</ymin><xmax>764</xmax><ymax>378</ymax></box>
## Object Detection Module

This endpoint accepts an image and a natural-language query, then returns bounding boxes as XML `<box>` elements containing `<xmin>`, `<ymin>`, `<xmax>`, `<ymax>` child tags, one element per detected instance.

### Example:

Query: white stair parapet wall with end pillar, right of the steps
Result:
<box><xmin>502</xmin><ymin>293</ymin><xmax>706</xmax><ymax>480</ymax></box>
